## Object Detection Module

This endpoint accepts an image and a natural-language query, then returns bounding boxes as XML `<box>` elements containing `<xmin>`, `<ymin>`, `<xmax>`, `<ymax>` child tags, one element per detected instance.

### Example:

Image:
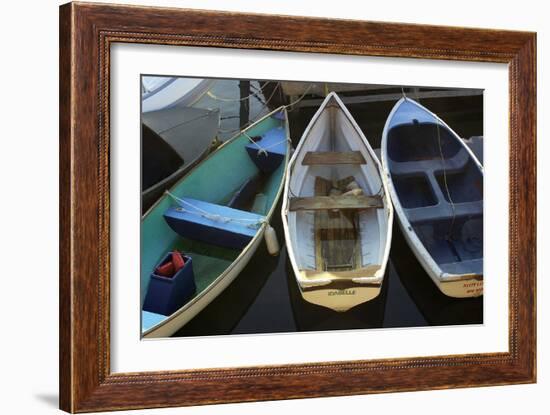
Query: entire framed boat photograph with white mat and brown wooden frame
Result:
<box><xmin>60</xmin><ymin>3</ymin><xmax>536</xmax><ymax>412</ymax></box>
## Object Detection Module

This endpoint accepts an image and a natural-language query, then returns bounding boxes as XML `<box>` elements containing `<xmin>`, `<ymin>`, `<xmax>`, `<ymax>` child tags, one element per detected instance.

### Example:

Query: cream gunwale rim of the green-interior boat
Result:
<box><xmin>140</xmin><ymin>105</ymin><xmax>291</xmax><ymax>340</ymax></box>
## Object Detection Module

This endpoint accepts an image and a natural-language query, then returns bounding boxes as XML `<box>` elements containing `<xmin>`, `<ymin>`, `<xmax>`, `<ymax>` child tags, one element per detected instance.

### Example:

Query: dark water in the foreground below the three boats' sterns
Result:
<box><xmin>175</xmin><ymin>208</ymin><xmax>483</xmax><ymax>336</ymax></box>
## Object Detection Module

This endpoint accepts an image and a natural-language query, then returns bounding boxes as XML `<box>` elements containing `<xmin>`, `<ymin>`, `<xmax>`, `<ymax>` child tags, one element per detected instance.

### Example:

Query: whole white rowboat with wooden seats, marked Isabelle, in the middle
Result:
<box><xmin>282</xmin><ymin>93</ymin><xmax>393</xmax><ymax>312</ymax></box>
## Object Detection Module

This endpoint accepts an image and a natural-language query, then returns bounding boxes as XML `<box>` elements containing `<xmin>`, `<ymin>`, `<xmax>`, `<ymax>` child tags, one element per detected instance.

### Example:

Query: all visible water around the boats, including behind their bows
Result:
<box><xmin>174</xmin><ymin>81</ymin><xmax>483</xmax><ymax>336</ymax></box>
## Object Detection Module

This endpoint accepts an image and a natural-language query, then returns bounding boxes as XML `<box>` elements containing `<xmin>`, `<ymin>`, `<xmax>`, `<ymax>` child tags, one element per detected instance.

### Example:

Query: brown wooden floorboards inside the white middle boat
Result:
<box><xmin>314</xmin><ymin>177</ymin><xmax>361</xmax><ymax>271</ymax></box>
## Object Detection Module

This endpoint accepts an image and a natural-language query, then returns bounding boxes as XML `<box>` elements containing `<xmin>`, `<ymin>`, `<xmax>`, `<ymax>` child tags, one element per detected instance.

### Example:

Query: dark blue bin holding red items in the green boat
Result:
<box><xmin>143</xmin><ymin>252</ymin><xmax>197</xmax><ymax>316</ymax></box>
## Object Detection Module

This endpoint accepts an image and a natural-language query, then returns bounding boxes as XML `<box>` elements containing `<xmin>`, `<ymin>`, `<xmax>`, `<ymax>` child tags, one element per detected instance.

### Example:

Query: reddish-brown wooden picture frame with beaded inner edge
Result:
<box><xmin>60</xmin><ymin>3</ymin><xmax>536</xmax><ymax>412</ymax></box>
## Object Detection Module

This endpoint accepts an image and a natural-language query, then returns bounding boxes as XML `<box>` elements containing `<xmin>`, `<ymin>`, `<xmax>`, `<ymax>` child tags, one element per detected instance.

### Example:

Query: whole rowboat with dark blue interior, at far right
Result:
<box><xmin>381</xmin><ymin>98</ymin><xmax>483</xmax><ymax>298</ymax></box>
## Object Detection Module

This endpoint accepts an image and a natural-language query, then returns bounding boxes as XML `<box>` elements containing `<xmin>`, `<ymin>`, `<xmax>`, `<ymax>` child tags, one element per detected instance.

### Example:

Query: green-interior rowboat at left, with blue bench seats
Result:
<box><xmin>140</xmin><ymin>107</ymin><xmax>290</xmax><ymax>337</ymax></box>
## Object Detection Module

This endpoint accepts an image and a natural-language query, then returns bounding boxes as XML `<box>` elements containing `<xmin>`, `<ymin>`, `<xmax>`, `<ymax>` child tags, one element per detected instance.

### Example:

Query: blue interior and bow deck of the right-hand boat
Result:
<box><xmin>387</xmin><ymin>100</ymin><xmax>483</xmax><ymax>274</ymax></box>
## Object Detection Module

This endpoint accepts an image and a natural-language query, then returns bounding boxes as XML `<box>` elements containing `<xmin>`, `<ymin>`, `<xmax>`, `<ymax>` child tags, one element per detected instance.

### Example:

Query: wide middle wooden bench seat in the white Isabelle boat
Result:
<box><xmin>289</xmin><ymin>195</ymin><xmax>384</xmax><ymax>211</ymax></box>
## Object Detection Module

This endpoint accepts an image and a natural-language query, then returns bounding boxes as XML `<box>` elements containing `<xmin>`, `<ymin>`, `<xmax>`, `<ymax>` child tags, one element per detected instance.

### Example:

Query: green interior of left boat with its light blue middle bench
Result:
<box><xmin>141</xmin><ymin>114</ymin><xmax>287</xmax><ymax>332</ymax></box>
